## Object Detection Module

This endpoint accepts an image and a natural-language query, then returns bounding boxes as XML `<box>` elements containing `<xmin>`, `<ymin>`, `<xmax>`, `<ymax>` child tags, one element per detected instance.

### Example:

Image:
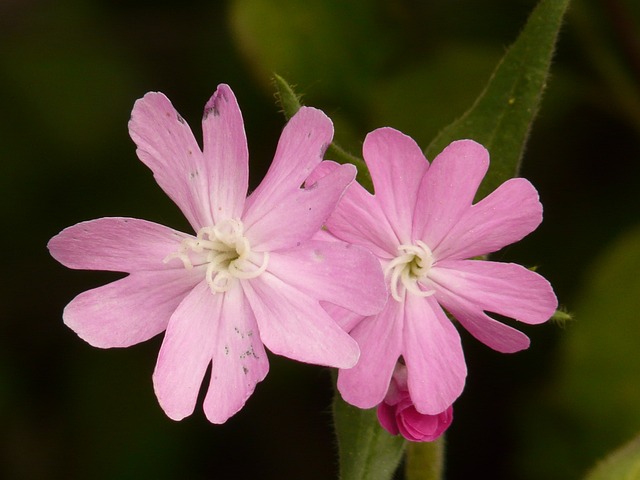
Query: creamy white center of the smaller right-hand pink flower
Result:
<box><xmin>384</xmin><ymin>240</ymin><xmax>436</xmax><ymax>302</ymax></box>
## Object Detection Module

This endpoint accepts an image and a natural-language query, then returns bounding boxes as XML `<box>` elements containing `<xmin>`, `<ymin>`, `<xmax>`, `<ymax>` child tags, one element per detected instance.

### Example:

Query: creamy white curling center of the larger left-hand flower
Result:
<box><xmin>163</xmin><ymin>218</ymin><xmax>269</xmax><ymax>293</ymax></box>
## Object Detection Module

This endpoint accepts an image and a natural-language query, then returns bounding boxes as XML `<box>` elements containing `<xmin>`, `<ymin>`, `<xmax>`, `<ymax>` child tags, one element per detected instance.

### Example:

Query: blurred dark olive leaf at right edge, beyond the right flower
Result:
<box><xmin>519</xmin><ymin>228</ymin><xmax>640</xmax><ymax>480</ymax></box>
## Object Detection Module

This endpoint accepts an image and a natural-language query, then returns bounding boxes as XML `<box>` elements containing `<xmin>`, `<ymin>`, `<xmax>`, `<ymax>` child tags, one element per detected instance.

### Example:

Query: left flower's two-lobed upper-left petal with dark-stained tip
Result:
<box><xmin>129</xmin><ymin>85</ymin><xmax>248</xmax><ymax>231</ymax></box>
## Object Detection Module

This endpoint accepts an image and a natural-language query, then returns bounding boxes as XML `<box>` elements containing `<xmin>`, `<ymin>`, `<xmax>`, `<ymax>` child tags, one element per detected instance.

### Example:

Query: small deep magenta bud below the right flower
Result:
<box><xmin>377</xmin><ymin>363</ymin><xmax>453</xmax><ymax>442</ymax></box>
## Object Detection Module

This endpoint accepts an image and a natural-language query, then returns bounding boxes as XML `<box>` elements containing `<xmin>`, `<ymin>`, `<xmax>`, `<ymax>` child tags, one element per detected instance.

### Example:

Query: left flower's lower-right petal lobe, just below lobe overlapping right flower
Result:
<box><xmin>242</xmin><ymin>271</ymin><xmax>359</xmax><ymax>368</ymax></box>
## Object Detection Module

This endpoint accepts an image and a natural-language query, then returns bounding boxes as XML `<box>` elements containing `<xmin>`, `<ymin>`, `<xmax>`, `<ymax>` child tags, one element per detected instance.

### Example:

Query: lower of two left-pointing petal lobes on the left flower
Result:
<box><xmin>63</xmin><ymin>269</ymin><xmax>202</xmax><ymax>348</ymax></box>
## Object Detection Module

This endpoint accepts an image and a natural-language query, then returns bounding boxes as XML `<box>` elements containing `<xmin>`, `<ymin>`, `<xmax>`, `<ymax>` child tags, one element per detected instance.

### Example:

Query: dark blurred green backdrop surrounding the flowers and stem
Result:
<box><xmin>0</xmin><ymin>0</ymin><xmax>640</xmax><ymax>480</ymax></box>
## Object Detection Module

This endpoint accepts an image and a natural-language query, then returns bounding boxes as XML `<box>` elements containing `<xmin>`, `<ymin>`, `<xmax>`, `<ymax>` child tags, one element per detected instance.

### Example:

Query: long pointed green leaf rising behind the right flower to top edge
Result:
<box><xmin>426</xmin><ymin>0</ymin><xmax>569</xmax><ymax>198</ymax></box>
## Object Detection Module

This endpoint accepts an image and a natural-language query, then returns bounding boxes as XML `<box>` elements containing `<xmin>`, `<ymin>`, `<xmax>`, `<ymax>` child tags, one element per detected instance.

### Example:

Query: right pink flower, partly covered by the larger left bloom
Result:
<box><xmin>310</xmin><ymin>128</ymin><xmax>557</xmax><ymax>415</ymax></box>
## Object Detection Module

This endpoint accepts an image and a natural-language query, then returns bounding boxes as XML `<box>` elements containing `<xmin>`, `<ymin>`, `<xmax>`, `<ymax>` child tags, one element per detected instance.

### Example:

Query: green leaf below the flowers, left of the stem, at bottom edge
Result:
<box><xmin>333</xmin><ymin>392</ymin><xmax>407</xmax><ymax>480</ymax></box>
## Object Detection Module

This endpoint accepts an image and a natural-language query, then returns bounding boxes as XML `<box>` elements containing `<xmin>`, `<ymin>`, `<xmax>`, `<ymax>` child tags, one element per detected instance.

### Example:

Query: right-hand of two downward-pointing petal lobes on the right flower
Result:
<box><xmin>402</xmin><ymin>295</ymin><xmax>467</xmax><ymax>415</ymax></box>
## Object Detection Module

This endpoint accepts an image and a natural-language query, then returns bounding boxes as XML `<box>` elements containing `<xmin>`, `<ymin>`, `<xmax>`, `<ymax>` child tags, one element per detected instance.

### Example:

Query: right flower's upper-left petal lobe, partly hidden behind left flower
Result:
<box><xmin>307</xmin><ymin>161</ymin><xmax>400</xmax><ymax>258</ymax></box>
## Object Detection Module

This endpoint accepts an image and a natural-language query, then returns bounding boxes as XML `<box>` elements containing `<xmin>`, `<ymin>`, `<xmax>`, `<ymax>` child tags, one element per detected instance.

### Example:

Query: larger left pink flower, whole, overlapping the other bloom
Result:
<box><xmin>49</xmin><ymin>85</ymin><xmax>386</xmax><ymax>423</ymax></box>
